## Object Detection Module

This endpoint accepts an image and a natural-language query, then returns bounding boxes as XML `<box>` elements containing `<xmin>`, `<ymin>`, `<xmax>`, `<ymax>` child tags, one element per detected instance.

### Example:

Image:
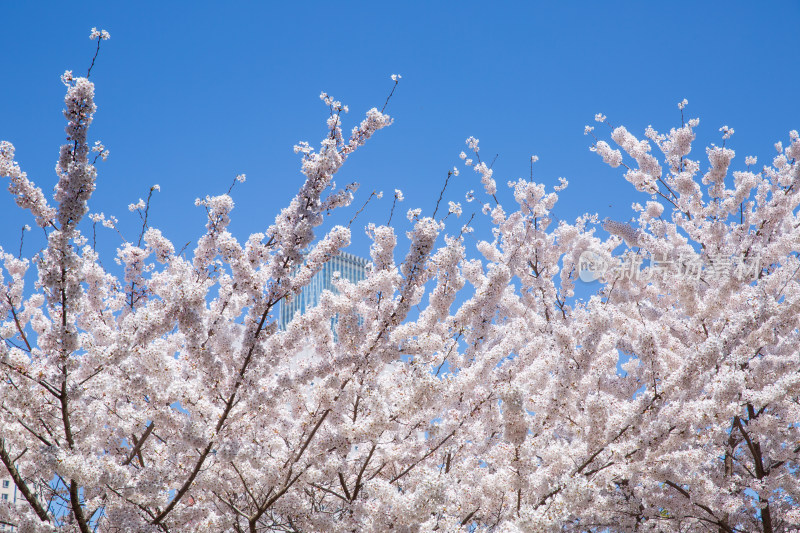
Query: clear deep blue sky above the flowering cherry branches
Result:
<box><xmin>0</xmin><ymin>1</ymin><xmax>800</xmax><ymax>263</ymax></box>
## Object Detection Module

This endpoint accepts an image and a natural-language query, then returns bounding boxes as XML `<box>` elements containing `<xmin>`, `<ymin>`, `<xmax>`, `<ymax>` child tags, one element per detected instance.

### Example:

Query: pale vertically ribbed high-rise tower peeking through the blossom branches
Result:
<box><xmin>278</xmin><ymin>252</ymin><xmax>367</xmax><ymax>329</ymax></box>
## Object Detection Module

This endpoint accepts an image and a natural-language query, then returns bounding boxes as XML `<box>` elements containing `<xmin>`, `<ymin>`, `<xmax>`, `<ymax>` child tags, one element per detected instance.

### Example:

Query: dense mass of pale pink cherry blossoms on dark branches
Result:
<box><xmin>0</xmin><ymin>29</ymin><xmax>800</xmax><ymax>533</ymax></box>
